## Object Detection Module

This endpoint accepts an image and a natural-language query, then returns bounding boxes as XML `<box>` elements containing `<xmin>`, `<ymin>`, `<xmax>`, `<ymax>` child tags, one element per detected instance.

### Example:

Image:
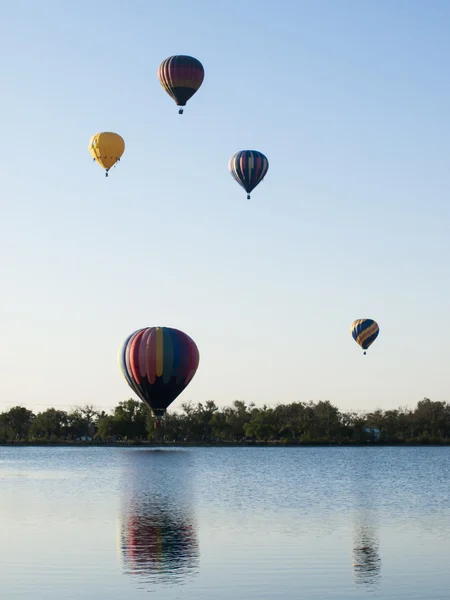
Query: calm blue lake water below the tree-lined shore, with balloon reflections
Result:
<box><xmin>0</xmin><ymin>447</ymin><xmax>450</xmax><ymax>600</ymax></box>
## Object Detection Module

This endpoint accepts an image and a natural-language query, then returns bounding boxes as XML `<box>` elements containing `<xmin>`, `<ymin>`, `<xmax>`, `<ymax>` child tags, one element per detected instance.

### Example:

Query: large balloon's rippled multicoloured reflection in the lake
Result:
<box><xmin>120</xmin><ymin>451</ymin><xmax>199</xmax><ymax>585</ymax></box>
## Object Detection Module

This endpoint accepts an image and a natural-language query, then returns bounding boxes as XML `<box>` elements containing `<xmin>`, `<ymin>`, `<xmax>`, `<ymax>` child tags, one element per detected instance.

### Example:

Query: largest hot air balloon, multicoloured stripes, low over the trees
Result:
<box><xmin>119</xmin><ymin>327</ymin><xmax>199</xmax><ymax>421</ymax></box>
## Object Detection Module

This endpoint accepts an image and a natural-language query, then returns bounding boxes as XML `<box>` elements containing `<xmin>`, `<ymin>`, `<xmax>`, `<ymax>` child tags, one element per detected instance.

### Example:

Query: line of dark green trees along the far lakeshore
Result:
<box><xmin>0</xmin><ymin>398</ymin><xmax>450</xmax><ymax>445</ymax></box>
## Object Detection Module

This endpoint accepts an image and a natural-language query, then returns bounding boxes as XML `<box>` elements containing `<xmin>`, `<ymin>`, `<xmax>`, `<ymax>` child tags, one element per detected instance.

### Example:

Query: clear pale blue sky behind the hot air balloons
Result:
<box><xmin>0</xmin><ymin>0</ymin><xmax>450</xmax><ymax>418</ymax></box>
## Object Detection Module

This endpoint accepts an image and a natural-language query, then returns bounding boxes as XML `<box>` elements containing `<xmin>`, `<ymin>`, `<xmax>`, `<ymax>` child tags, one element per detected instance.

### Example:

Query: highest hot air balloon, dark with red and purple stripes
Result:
<box><xmin>158</xmin><ymin>54</ymin><xmax>205</xmax><ymax>115</ymax></box>
